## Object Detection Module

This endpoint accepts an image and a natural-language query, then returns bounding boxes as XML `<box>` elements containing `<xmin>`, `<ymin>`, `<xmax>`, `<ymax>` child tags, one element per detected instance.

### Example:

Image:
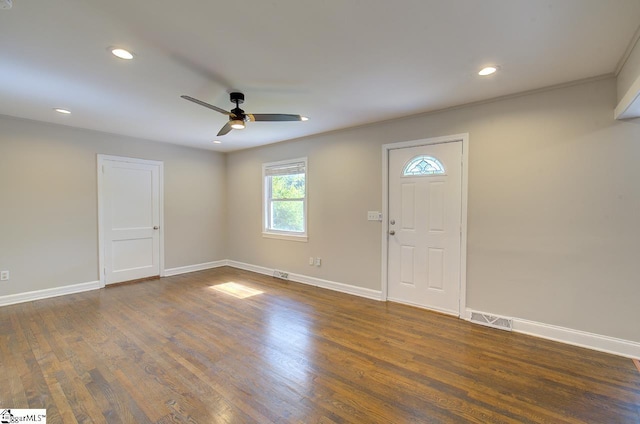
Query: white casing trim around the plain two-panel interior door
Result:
<box><xmin>96</xmin><ymin>154</ymin><xmax>164</xmax><ymax>288</ymax></box>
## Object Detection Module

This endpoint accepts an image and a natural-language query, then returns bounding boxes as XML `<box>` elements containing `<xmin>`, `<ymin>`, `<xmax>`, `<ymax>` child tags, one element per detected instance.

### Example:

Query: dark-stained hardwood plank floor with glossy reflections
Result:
<box><xmin>0</xmin><ymin>268</ymin><xmax>640</xmax><ymax>423</ymax></box>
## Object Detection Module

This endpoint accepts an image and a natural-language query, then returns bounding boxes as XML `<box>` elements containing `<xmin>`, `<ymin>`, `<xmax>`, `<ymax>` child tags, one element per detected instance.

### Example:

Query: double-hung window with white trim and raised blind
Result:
<box><xmin>262</xmin><ymin>158</ymin><xmax>307</xmax><ymax>241</ymax></box>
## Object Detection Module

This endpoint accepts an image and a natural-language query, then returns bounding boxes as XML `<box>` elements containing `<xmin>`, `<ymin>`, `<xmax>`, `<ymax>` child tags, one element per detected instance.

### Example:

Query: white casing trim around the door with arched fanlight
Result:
<box><xmin>381</xmin><ymin>133</ymin><xmax>469</xmax><ymax>317</ymax></box>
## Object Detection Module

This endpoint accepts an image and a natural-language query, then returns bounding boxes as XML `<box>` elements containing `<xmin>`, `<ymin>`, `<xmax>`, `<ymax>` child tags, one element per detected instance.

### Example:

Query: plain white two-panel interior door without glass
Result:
<box><xmin>98</xmin><ymin>157</ymin><xmax>162</xmax><ymax>284</ymax></box>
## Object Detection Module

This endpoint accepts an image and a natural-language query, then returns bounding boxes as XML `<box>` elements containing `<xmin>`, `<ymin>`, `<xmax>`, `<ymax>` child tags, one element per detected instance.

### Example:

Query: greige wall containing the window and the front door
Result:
<box><xmin>227</xmin><ymin>78</ymin><xmax>640</xmax><ymax>342</ymax></box>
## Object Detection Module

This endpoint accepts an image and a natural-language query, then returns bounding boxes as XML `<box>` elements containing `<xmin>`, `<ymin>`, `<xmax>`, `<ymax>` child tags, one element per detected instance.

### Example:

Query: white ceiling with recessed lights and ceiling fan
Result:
<box><xmin>0</xmin><ymin>0</ymin><xmax>640</xmax><ymax>151</ymax></box>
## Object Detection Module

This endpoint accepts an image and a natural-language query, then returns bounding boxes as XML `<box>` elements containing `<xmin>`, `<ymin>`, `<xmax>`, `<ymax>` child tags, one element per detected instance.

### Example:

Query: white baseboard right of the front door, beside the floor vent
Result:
<box><xmin>464</xmin><ymin>309</ymin><xmax>640</xmax><ymax>359</ymax></box>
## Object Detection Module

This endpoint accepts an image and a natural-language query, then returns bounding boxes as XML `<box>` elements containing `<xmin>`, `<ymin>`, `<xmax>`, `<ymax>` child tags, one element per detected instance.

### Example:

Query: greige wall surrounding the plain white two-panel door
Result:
<box><xmin>0</xmin><ymin>116</ymin><xmax>227</xmax><ymax>296</ymax></box>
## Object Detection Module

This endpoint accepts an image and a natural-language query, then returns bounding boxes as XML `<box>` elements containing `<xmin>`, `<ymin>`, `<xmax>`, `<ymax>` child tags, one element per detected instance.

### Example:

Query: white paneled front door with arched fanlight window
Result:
<box><xmin>387</xmin><ymin>141</ymin><xmax>462</xmax><ymax>315</ymax></box>
